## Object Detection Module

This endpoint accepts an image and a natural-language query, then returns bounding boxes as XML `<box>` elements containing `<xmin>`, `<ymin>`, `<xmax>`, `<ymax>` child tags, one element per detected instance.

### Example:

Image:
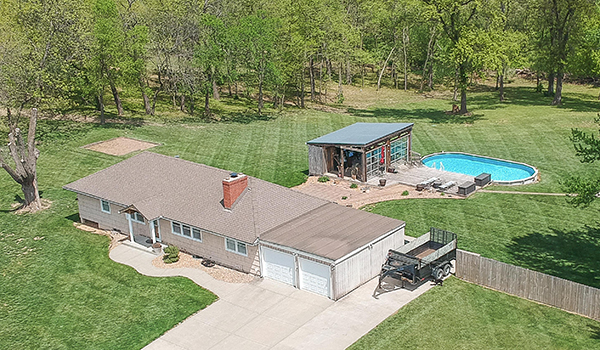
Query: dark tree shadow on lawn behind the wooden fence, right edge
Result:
<box><xmin>508</xmin><ymin>225</ymin><xmax>600</xmax><ymax>288</ymax></box>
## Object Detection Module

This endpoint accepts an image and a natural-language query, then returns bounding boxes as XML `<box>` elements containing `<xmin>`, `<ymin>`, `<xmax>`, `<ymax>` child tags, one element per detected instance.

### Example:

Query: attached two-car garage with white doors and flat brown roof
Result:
<box><xmin>260</xmin><ymin>203</ymin><xmax>405</xmax><ymax>300</ymax></box>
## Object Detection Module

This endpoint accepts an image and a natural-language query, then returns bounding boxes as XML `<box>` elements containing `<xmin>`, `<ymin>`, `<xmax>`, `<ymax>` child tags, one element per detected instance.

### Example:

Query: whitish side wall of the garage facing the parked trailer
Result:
<box><xmin>332</xmin><ymin>228</ymin><xmax>404</xmax><ymax>300</ymax></box>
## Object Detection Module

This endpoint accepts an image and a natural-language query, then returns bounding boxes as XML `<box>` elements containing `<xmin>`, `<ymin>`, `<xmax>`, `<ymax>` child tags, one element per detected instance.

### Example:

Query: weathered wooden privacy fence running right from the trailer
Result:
<box><xmin>456</xmin><ymin>249</ymin><xmax>600</xmax><ymax>320</ymax></box>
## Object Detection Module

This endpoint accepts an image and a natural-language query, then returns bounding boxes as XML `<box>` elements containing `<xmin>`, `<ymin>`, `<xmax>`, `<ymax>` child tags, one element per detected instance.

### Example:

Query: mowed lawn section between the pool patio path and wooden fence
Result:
<box><xmin>365</xmin><ymin>193</ymin><xmax>600</xmax><ymax>288</ymax></box>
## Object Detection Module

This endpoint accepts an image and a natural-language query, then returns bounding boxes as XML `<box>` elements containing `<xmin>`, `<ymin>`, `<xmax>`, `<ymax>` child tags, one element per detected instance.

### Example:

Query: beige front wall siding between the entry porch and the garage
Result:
<box><xmin>160</xmin><ymin>219</ymin><xmax>260</xmax><ymax>275</ymax></box>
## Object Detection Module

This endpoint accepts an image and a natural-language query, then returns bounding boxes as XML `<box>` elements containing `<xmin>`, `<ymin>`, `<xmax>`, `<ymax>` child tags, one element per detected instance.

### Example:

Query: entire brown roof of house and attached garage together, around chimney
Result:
<box><xmin>64</xmin><ymin>152</ymin><xmax>404</xmax><ymax>260</ymax></box>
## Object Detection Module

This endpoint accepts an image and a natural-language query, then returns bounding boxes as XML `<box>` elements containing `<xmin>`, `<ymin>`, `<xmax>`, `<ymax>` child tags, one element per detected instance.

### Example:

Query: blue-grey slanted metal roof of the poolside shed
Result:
<box><xmin>307</xmin><ymin>123</ymin><xmax>414</xmax><ymax>146</ymax></box>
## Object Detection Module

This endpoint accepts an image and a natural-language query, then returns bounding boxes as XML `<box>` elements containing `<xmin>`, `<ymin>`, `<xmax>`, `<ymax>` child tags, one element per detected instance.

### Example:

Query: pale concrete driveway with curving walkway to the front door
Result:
<box><xmin>110</xmin><ymin>245</ymin><xmax>432</xmax><ymax>350</ymax></box>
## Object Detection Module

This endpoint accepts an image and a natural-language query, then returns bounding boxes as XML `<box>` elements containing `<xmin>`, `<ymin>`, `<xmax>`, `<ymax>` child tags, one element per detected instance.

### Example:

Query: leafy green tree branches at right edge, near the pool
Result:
<box><xmin>562</xmin><ymin>115</ymin><xmax>600</xmax><ymax>207</ymax></box>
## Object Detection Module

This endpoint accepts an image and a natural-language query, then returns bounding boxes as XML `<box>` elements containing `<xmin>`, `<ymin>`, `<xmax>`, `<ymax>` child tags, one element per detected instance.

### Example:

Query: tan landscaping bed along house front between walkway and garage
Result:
<box><xmin>152</xmin><ymin>252</ymin><xmax>256</xmax><ymax>283</ymax></box>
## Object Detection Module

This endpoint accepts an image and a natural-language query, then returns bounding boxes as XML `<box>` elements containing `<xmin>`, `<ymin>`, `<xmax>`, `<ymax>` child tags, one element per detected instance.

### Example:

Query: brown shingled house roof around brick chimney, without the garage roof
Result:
<box><xmin>64</xmin><ymin>152</ymin><xmax>328</xmax><ymax>243</ymax></box>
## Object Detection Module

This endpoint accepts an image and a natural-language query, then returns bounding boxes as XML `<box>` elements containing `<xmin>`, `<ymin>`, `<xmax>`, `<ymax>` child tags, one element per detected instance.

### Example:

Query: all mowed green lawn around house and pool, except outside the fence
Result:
<box><xmin>0</xmin><ymin>79</ymin><xmax>600</xmax><ymax>349</ymax></box>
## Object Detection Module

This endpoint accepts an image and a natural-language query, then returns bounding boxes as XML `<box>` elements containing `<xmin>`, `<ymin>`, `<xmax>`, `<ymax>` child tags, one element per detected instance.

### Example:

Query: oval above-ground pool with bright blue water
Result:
<box><xmin>423</xmin><ymin>152</ymin><xmax>537</xmax><ymax>185</ymax></box>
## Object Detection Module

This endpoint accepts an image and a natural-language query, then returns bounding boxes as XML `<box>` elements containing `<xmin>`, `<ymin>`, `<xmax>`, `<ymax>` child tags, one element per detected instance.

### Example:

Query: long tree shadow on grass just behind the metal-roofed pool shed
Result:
<box><xmin>348</xmin><ymin>108</ymin><xmax>484</xmax><ymax>124</ymax></box>
